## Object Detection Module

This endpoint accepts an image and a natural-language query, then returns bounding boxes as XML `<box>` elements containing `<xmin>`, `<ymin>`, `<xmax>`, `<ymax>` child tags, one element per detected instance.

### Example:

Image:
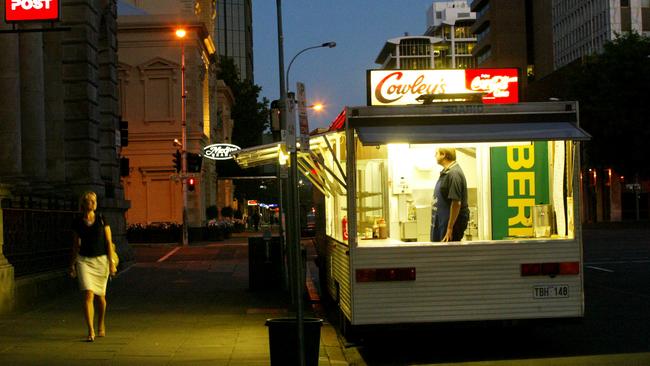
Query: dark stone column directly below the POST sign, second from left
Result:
<box><xmin>19</xmin><ymin>27</ymin><xmax>47</xmax><ymax>186</ymax></box>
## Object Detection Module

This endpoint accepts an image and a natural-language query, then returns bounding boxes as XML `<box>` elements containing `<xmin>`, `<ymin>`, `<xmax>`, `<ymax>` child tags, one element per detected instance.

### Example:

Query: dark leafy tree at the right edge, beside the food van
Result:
<box><xmin>567</xmin><ymin>32</ymin><xmax>650</xmax><ymax>176</ymax></box>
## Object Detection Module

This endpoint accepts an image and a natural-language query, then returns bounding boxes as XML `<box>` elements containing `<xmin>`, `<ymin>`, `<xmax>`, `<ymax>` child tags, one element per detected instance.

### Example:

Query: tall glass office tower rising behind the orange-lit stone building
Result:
<box><xmin>216</xmin><ymin>0</ymin><xmax>254</xmax><ymax>81</ymax></box>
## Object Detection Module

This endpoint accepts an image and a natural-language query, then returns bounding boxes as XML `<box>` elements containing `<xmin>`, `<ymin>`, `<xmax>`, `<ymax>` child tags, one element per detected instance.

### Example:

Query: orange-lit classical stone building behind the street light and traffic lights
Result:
<box><xmin>118</xmin><ymin>1</ymin><xmax>234</xmax><ymax>227</ymax></box>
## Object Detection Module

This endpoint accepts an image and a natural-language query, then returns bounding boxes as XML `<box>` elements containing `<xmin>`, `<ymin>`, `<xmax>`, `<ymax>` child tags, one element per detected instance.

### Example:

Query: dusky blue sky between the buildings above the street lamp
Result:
<box><xmin>253</xmin><ymin>0</ymin><xmax>433</xmax><ymax>129</ymax></box>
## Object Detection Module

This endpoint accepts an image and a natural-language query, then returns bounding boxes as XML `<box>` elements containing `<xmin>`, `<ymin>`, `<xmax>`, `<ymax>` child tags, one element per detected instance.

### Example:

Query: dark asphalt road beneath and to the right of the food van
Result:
<box><xmin>326</xmin><ymin>225</ymin><xmax>650</xmax><ymax>365</ymax></box>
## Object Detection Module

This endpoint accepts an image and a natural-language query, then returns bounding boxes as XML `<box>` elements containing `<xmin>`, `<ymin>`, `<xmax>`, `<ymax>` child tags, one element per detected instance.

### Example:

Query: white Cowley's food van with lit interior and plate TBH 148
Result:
<box><xmin>236</xmin><ymin>70</ymin><xmax>589</xmax><ymax>332</ymax></box>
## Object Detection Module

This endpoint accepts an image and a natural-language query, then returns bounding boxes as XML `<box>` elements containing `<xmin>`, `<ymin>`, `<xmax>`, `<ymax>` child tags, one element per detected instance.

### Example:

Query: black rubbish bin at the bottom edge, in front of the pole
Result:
<box><xmin>266</xmin><ymin>318</ymin><xmax>323</xmax><ymax>366</ymax></box>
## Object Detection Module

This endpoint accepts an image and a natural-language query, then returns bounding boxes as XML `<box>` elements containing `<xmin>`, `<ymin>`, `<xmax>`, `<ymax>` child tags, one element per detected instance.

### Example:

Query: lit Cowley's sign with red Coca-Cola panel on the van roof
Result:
<box><xmin>367</xmin><ymin>69</ymin><xmax>519</xmax><ymax>105</ymax></box>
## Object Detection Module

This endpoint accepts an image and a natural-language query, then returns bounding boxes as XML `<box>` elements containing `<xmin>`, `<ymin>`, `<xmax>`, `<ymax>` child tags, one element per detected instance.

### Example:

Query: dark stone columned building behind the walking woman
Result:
<box><xmin>0</xmin><ymin>0</ymin><xmax>129</xmax><ymax>312</ymax></box>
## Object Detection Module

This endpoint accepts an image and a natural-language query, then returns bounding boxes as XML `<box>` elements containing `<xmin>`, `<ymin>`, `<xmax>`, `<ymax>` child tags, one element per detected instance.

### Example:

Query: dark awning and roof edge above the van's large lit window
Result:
<box><xmin>347</xmin><ymin>102</ymin><xmax>591</xmax><ymax>145</ymax></box>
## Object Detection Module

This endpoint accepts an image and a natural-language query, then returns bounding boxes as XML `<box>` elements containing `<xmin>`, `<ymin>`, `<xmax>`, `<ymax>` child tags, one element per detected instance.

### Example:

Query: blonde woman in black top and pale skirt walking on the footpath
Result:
<box><xmin>70</xmin><ymin>192</ymin><xmax>117</xmax><ymax>342</ymax></box>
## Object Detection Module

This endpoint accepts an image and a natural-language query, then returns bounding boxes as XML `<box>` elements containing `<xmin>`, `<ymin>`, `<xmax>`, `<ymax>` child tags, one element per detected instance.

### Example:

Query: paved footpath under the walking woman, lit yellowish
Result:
<box><xmin>0</xmin><ymin>235</ymin><xmax>348</xmax><ymax>366</ymax></box>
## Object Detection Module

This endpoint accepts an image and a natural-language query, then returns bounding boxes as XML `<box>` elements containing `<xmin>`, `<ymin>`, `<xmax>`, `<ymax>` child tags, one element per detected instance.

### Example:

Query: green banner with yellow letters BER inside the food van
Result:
<box><xmin>490</xmin><ymin>141</ymin><xmax>550</xmax><ymax>240</ymax></box>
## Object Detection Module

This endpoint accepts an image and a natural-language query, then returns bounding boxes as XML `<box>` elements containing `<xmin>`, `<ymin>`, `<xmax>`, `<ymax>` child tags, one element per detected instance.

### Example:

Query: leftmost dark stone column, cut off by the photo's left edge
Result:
<box><xmin>0</xmin><ymin>28</ymin><xmax>22</xmax><ymax>177</ymax></box>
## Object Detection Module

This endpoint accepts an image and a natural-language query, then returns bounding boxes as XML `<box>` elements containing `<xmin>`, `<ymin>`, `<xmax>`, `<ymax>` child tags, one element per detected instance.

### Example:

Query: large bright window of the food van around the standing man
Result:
<box><xmin>356</xmin><ymin>141</ymin><xmax>574</xmax><ymax>245</ymax></box>
